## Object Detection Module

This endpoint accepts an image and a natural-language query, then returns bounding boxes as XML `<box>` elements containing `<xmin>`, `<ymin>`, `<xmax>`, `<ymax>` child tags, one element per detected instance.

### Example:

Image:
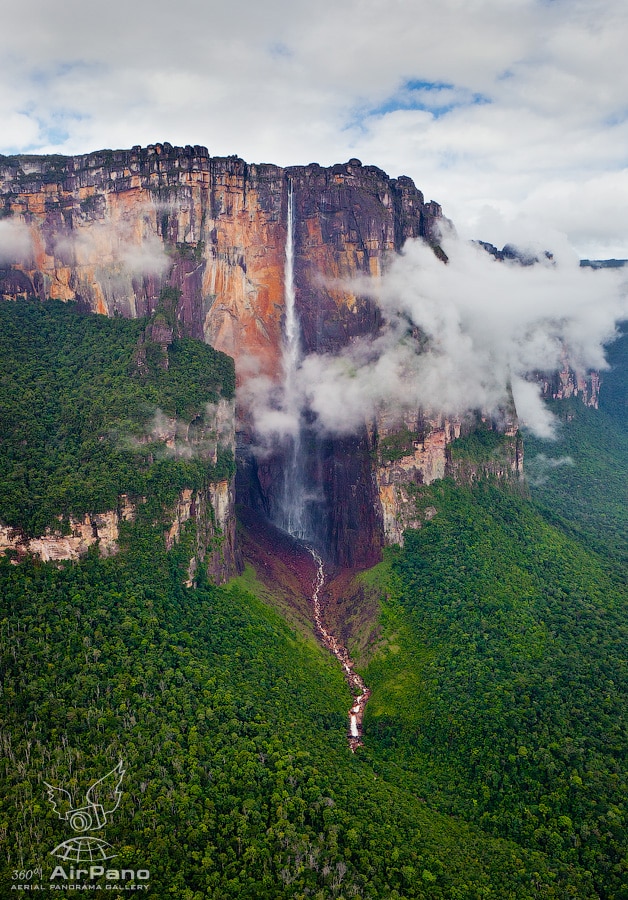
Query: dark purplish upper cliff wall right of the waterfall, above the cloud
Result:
<box><xmin>287</xmin><ymin>159</ymin><xmax>442</xmax><ymax>352</ymax></box>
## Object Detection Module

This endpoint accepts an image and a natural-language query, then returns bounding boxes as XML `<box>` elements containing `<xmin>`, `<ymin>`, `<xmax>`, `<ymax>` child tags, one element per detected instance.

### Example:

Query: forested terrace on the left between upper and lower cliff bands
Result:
<box><xmin>0</xmin><ymin>301</ymin><xmax>234</xmax><ymax>535</ymax></box>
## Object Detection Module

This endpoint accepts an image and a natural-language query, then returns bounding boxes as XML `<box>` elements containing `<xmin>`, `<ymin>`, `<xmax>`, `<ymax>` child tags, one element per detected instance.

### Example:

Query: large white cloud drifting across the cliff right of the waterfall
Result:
<box><xmin>242</xmin><ymin>235</ymin><xmax>628</xmax><ymax>453</ymax></box>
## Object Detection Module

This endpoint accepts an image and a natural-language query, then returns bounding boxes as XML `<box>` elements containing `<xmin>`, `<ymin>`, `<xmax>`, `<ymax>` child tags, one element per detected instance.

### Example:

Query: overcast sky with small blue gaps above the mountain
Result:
<box><xmin>0</xmin><ymin>0</ymin><xmax>628</xmax><ymax>258</ymax></box>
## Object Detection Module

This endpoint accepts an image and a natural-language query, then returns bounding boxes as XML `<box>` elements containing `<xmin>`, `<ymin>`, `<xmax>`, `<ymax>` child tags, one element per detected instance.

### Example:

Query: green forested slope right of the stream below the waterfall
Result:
<box><xmin>365</xmin><ymin>482</ymin><xmax>628</xmax><ymax>897</ymax></box>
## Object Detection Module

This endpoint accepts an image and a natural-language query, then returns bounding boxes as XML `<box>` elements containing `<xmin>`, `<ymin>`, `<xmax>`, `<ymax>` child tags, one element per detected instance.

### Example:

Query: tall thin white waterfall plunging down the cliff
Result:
<box><xmin>277</xmin><ymin>181</ymin><xmax>308</xmax><ymax>538</ymax></box>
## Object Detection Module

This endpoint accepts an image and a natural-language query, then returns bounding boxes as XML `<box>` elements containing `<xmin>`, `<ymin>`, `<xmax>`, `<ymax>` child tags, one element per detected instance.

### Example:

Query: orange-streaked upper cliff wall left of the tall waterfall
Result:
<box><xmin>0</xmin><ymin>144</ymin><xmax>285</xmax><ymax>370</ymax></box>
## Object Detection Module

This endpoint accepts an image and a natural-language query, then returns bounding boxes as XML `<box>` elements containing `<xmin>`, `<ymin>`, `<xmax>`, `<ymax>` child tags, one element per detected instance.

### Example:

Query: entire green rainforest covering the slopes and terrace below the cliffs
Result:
<box><xmin>0</xmin><ymin>303</ymin><xmax>628</xmax><ymax>900</ymax></box>
